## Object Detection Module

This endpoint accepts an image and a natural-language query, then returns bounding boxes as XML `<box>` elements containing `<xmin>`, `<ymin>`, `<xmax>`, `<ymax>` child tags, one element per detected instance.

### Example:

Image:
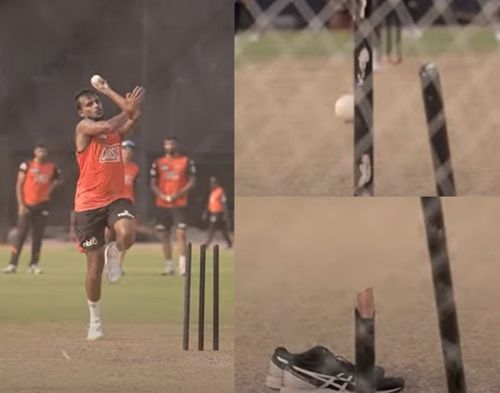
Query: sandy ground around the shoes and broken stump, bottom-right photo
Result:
<box><xmin>235</xmin><ymin>197</ymin><xmax>500</xmax><ymax>393</ymax></box>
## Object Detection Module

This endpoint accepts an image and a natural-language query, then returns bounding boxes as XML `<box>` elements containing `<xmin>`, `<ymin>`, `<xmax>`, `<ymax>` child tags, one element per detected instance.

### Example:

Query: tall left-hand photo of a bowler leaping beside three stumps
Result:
<box><xmin>0</xmin><ymin>0</ymin><xmax>234</xmax><ymax>393</ymax></box>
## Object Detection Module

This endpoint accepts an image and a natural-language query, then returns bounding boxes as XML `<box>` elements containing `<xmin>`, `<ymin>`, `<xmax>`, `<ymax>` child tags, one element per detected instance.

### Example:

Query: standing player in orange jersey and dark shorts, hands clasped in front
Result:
<box><xmin>150</xmin><ymin>136</ymin><xmax>196</xmax><ymax>275</ymax></box>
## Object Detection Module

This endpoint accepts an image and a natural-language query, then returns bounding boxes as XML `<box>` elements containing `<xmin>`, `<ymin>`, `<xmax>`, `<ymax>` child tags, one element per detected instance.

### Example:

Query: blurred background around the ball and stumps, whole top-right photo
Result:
<box><xmin>235</xmin><ymin>0</ymin><xmax>500</xmax><ymax>196</ymax></box>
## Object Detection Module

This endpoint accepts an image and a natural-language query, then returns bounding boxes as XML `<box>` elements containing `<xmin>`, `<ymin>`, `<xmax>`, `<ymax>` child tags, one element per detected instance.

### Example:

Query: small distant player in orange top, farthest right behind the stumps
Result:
<box><xmin>203</xmin><ymin>176</ymin><xmax>233</xmax><ymax>248</ymax></box>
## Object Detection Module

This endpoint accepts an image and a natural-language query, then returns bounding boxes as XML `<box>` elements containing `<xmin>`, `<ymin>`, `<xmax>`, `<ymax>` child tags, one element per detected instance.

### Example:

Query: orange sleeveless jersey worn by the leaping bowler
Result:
<box><xmin>75</xmin><ymin>132</ymin><xmax>125</xmax><ymax>212</ymax></box>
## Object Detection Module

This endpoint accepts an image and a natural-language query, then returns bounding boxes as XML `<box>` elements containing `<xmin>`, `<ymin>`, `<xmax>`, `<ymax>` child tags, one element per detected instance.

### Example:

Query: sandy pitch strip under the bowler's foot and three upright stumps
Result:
<box><xmin>0</xmin><ymin>324</ymin><xmax>234</xmax><ymax>393</ymax></box>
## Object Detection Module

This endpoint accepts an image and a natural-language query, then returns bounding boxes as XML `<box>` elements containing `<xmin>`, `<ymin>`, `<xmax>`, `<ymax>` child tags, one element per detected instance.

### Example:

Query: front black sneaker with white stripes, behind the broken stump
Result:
<box><xmin>281</xmin><ymin>366</ymin><xmax>405</xmax><ymax>393</ymax></box>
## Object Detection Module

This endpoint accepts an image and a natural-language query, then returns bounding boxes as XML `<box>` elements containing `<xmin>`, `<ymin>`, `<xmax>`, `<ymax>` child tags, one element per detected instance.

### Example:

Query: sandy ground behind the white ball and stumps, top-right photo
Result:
<box><xmin>235</xmin><ymin>53</ymin><xmax>500</xmax><ymax>196</ymax></box>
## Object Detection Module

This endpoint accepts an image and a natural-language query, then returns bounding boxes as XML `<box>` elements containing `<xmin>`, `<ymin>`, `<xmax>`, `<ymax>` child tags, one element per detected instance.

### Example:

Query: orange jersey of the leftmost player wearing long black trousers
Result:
<box><xmin>19</xmin><ymin>160</ymin><xmax>60</xmax><ymax>206</ymax></box>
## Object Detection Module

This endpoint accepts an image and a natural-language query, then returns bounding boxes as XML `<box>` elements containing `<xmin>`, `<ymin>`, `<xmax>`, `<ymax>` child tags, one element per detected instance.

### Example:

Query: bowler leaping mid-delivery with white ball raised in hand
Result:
<box><xmin>75</xmin><ymin>79</ymin><xmax>144</xmax><ymax>340</ymax></box>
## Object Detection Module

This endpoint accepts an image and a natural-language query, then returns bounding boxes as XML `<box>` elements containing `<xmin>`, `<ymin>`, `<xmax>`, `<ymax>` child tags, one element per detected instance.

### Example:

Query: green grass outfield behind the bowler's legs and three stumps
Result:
<box><xmin>0</xmin><ymin>243</ymin><xmax>234</xmax><ymax>326</ymax></box>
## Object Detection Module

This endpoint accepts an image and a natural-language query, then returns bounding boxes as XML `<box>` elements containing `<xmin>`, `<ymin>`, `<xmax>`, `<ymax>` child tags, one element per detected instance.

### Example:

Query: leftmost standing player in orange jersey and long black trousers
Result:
<box><xmin>2</xmin><ymin>143</ymin><xmax>62</xmax><ymax>274</ymax></box>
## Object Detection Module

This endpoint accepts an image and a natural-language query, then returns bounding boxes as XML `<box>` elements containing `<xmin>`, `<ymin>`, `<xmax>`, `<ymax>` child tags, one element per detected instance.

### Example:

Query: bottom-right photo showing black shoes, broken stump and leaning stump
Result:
<box><xmin>235</xmin><ymin>197</ymin><xmax>500</xmax><ymax>393</ymax></box>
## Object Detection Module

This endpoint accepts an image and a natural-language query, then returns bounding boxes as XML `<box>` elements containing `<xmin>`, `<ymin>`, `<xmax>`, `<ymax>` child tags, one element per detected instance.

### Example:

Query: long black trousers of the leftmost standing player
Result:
<box><xmin>9</xmin><ymin>202</ymin><xmax>49</xmax><ymax>266</ymax></box>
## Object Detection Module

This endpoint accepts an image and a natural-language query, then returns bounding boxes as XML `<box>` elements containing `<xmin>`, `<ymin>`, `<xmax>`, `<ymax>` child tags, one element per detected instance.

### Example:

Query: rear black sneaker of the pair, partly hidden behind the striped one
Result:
<box><xmin>266</xmin><ymin>346</ymin><xmax>385</xmax><ymax>389</ymax></box>
